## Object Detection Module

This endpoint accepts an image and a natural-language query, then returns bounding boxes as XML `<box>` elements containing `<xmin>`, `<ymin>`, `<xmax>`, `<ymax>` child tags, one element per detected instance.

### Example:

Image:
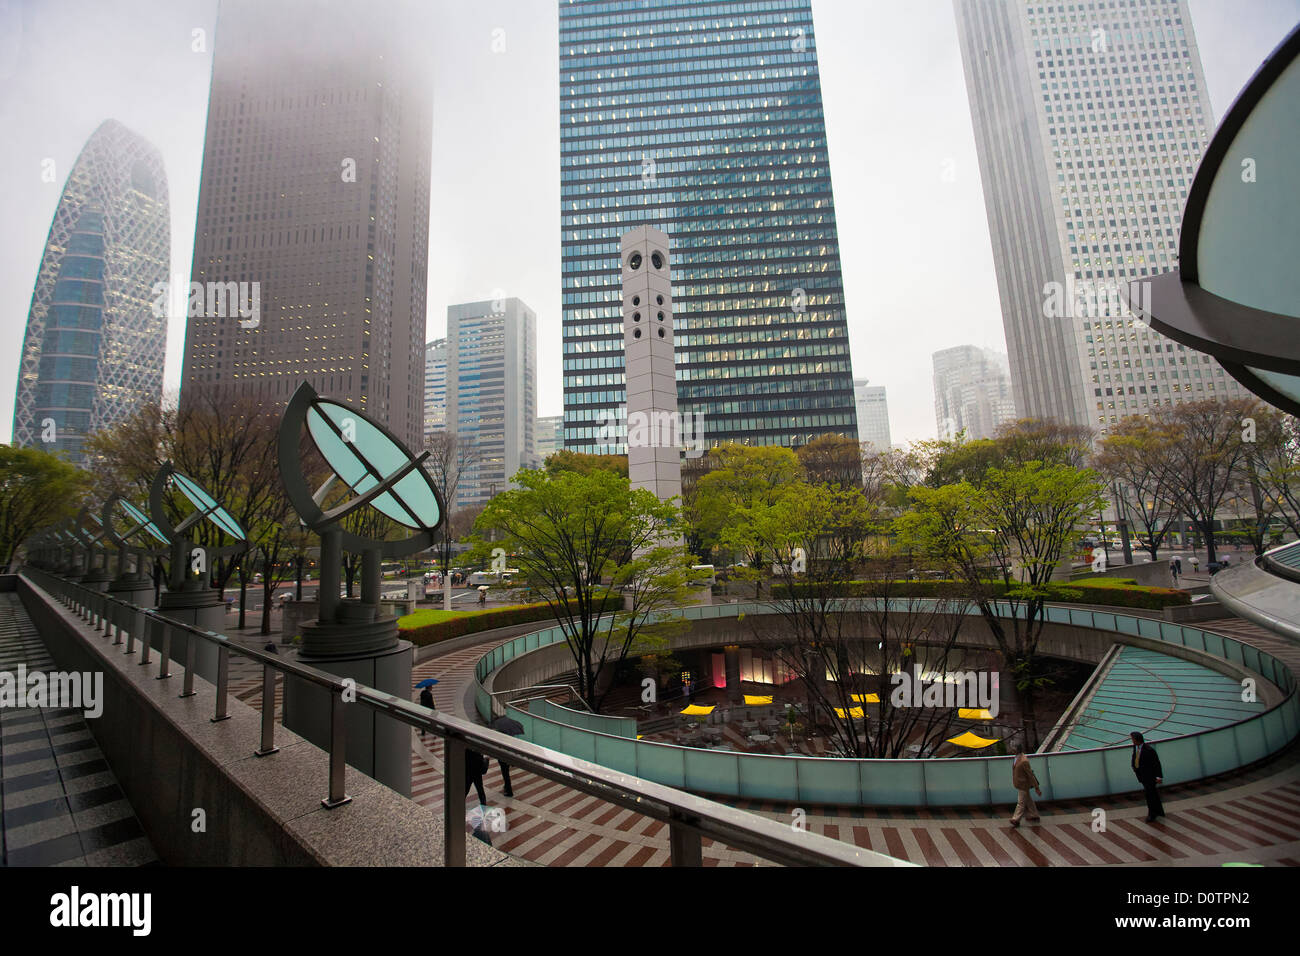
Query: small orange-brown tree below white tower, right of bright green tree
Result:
<box><xmin>1093</xmin><ymin>415</ymin><xmax>1178</xmax><ymax>561</ymax></box>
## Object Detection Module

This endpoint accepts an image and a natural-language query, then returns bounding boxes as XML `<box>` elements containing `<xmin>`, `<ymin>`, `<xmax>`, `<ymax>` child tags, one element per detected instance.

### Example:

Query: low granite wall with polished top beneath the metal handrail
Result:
<box><xmin>20</xmin><ymin>579</ymin><xmax>517</xmax><ymax>866</ymax></box>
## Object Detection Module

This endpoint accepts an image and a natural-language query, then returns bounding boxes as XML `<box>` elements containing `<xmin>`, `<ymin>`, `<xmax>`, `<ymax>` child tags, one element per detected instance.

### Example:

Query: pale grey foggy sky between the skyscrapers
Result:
<box><xmin>0</xmin><ymin>0</ymin><xmax>1300</xmax><ymax>442</ymax></box>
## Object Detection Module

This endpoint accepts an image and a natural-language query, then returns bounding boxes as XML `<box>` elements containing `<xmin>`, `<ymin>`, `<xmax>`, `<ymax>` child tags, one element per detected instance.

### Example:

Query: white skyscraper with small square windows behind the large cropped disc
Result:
<box><xmin>956</xmin><ymin>0</ymin><xmax>1244</xmax><ymax>429</ymax></box>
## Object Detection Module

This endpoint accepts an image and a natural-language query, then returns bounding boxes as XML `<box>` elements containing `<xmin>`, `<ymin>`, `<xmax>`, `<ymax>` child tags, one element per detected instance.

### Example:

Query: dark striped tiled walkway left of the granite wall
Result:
<box><xmin>0</xmin><ymin>592</ymin><xmax>157</xmax><ymax>866</ymax></box>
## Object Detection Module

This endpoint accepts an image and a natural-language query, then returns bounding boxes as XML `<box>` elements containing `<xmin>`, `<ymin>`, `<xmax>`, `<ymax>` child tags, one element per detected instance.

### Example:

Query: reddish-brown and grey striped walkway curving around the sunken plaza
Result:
<box><xmin>412</xmin><ymin>619</ymin><xmax>1300</xmax><ymax>866</ymax></box>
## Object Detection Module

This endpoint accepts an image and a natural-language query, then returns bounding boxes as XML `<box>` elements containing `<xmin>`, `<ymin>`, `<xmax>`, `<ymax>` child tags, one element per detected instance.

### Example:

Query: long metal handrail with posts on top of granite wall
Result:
<box><xmin>22</xmin><ymin>567</ymin><xmax>913</xmax><ymax>866</ymax></box>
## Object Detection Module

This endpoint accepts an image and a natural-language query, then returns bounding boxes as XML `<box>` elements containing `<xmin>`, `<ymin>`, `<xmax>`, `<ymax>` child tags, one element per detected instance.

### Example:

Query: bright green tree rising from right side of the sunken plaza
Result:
<box><xmin>894</xmin><ymin>460</ymin><xmax>1104</xmax><ymax>749</ymax></box>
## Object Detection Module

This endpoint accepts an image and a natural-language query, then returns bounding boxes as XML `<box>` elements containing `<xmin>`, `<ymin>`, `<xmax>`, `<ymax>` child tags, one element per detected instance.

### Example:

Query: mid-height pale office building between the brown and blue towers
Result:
<box><xmin>447</xmin><ymin>298</ymin><xmax>538</xmax><ymax>510</ymax></box>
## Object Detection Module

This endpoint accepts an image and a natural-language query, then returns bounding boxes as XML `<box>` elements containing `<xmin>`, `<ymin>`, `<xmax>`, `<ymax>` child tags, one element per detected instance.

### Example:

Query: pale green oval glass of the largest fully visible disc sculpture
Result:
<box><xmin>307</xmin><ymin>398</ymin><xmax>441</xmax><ymax>531</ymax></box>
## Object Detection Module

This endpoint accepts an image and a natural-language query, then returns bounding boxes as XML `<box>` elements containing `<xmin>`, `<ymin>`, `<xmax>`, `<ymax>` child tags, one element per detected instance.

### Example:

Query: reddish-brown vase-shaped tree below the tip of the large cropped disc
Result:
<box><xmin>1154</xmin><ymin>398</ymin><xmax>1258</xmax><ymax>562</ymax></box>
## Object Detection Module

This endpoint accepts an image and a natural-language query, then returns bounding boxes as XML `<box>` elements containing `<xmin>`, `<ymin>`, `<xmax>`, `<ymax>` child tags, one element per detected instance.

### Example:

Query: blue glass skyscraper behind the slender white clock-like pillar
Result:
<box><xmin>559</xmin><ymin>0</ymin><xmax>857</xmax><ymax>454</ymax></box>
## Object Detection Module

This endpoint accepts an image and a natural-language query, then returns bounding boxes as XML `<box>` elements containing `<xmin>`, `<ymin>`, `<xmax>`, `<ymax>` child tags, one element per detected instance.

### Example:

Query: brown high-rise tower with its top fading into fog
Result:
<box><xmin>181</xmin><ymin>0</ymin><xmax>433</xmax><ymax>446</ymax></box>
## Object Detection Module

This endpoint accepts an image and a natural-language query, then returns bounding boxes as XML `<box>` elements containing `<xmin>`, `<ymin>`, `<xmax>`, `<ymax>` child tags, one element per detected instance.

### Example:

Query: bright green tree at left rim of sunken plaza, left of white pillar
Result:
<box><xmin>475</xmin><ymin>468</ymin><xmax>692</xmax><ymax>711</ymax></box>
